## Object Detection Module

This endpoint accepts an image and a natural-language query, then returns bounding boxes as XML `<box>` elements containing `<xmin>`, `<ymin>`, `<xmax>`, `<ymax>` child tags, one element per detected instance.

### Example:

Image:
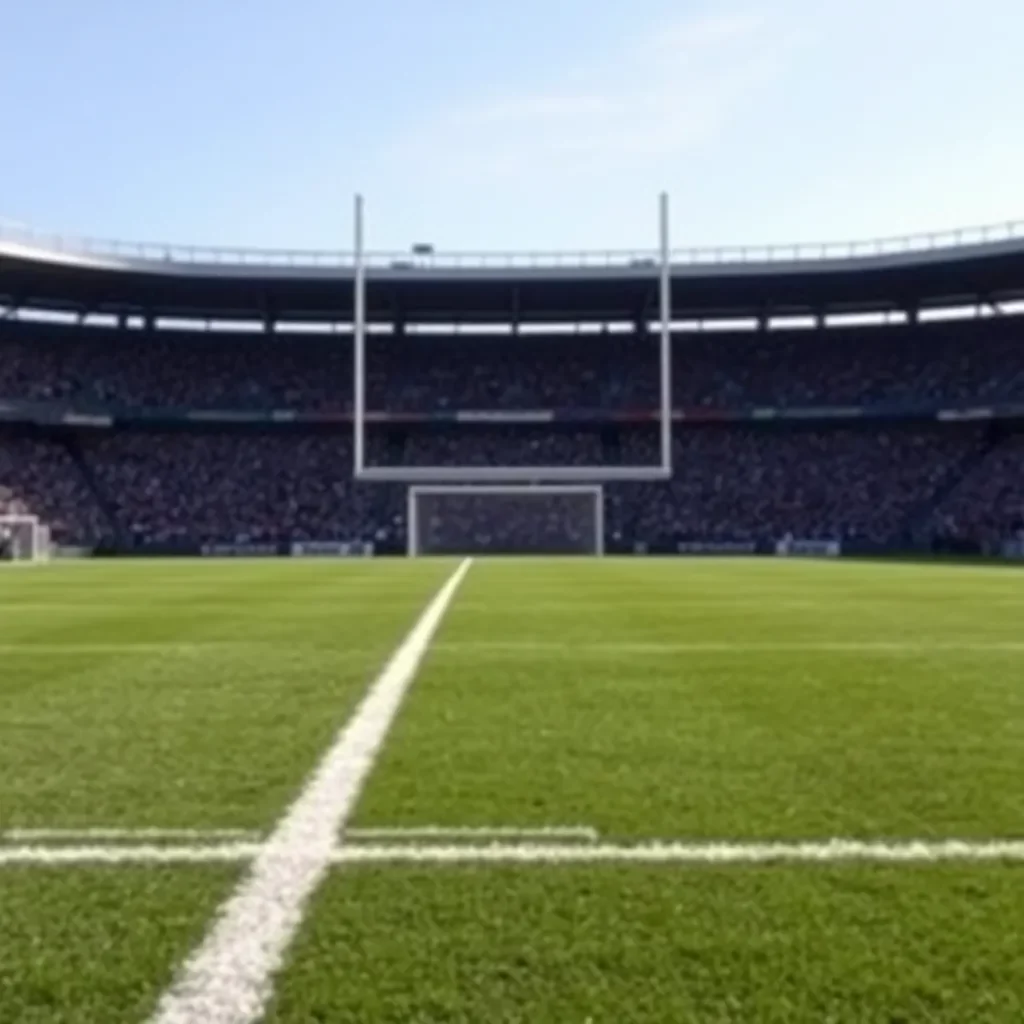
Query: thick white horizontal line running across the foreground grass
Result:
<box><xmin>0</xmin><ymin>839</ymin><xmax>1024</xmax><ymax>868</ymax></box>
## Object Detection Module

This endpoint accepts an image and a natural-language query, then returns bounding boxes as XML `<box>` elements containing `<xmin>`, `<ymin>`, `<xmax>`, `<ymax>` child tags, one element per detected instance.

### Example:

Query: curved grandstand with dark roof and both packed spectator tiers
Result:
<box><xmin>0</xmin><ymin>227</ymin><xmax>1024</xmax><ymax>552</ymax></box>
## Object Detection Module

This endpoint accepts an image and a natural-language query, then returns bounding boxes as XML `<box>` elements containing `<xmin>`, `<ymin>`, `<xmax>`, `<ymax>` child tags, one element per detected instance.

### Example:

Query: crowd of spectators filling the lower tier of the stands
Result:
<box><xmin>0</xmin><ymin>425</ymin><xmax>1024</xmax><ymax>549</ymax></box>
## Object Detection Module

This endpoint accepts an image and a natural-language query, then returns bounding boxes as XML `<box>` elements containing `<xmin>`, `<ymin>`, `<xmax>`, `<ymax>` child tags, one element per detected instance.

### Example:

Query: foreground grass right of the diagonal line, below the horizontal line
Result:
<box><xmin>269</xmin><ymin>866</ymin><xmax>1024</xmax><ymax>1024</ymax></box>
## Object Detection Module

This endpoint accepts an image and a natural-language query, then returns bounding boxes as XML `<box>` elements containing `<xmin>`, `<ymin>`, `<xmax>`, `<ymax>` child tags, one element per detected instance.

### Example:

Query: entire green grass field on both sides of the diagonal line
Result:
<box><xmin>0</xmin><ymin>558</ymin><xmax>1024</xmax><ymax>1024</ymax></box>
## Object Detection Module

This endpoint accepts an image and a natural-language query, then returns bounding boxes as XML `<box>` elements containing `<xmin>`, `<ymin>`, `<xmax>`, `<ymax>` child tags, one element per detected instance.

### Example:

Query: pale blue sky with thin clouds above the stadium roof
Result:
<box><xmin>0</xmin><ymin>0</ymin><xmax>1024</xmax><ymax>250</ymax></box>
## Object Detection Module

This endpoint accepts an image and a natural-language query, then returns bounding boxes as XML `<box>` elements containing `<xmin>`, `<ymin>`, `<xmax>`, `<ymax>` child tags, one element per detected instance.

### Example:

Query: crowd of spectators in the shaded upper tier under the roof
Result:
<box><xmin>0</xmin><ymin>318</ymin><xmax>1024</xmax><ymax>413</ymax></box>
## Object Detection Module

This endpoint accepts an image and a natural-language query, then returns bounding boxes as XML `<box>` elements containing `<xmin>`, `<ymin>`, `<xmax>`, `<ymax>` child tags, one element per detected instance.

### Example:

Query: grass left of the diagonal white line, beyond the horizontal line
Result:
<box><xmin>0</xmin><ymin>562</ymin><xmax>450</xmax><ymax>828</ymax></box>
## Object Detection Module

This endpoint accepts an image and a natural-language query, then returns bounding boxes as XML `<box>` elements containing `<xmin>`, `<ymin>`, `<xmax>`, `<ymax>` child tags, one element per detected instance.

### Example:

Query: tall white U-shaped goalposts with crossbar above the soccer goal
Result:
<box><xmin>352</xmin><ymin>193</ymin><xmax>672</xmax><ymax>483</ymax></box>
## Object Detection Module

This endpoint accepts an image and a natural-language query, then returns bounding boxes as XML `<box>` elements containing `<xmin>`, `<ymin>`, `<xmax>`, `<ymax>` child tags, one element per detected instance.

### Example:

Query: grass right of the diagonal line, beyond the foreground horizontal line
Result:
<box><xmin>358</xmin><ymin>561</ymin><xmax>1024</xmax><ymax>840</ymax></box>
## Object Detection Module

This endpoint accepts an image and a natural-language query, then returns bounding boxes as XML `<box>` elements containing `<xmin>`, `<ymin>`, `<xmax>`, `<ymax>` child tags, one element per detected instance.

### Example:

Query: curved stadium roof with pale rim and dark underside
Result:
<box><xmin>0</xmin><ymin>223</ymin><xmax>1024</xmax><ymax>323</ymax></box>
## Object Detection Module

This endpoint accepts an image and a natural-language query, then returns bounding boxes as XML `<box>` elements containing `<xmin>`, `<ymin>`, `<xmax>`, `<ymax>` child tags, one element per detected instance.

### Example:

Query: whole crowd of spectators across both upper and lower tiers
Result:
<box><xmin>0</xmin><ymin>318</ymin><xmax>1024</xmax><ymax>547</ymax></box>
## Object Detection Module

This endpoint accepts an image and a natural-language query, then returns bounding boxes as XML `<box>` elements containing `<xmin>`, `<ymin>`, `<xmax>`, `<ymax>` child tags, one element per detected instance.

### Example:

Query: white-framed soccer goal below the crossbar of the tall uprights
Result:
<box><xmin>407</xmin><ymin>483</ymin><xmax>604</xmax><ymax>557</ymax></box>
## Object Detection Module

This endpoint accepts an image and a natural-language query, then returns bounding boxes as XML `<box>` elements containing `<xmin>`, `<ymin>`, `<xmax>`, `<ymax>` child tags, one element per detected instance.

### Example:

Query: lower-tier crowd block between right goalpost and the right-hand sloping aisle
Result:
<box><xmin>609</xmin><ymin>426</ymin><xmax>984</xmax><ymax>544</ymax></box>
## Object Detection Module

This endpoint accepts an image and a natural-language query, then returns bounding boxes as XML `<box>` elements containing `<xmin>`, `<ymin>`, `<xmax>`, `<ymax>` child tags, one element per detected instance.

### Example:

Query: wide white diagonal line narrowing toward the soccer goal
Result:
<box><xmin>150</xmin><ymin>558</ymin><xmax>472</xmax><ymax>1024</ymax></box>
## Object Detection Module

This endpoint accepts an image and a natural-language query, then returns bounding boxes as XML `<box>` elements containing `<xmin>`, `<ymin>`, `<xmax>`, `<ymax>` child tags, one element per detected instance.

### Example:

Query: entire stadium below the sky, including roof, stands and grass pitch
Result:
<box><xmin>0</xmin><ymin>204</ymin><xmax>1024</xmax><ymax>1024</ymax></box>
